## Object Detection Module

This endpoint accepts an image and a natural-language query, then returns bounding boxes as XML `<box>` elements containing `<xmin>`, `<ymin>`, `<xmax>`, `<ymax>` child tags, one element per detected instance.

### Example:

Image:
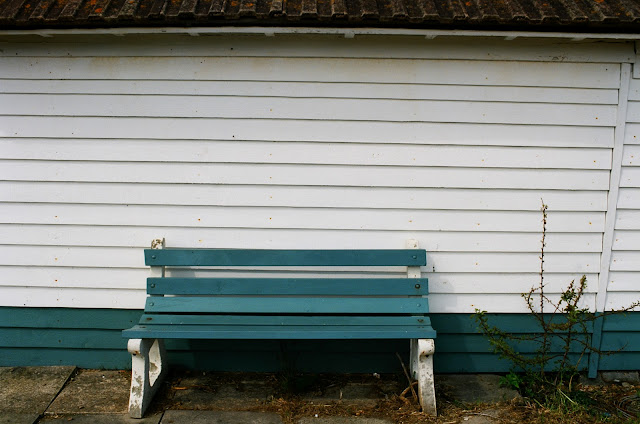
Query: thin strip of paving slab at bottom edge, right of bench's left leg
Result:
<box><xmin>160</xmin><ymin>410</ymin><xmax>282</xmax><ymax>424</ymax></box>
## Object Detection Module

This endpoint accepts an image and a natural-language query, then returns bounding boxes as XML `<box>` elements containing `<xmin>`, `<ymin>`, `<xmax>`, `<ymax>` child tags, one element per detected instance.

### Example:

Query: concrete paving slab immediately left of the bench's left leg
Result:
<box><xmin>47</xmin><ymin>370</ymin><xmax>131</xmax><ymax>415</ymax></box>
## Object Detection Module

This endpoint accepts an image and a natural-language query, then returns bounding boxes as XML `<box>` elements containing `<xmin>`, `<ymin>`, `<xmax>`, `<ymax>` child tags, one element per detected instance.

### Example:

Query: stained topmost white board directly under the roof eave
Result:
<box><xmin>0</xmin><ymin>34</ymin><xmax>635</xmax><ymax>63</ymax></box>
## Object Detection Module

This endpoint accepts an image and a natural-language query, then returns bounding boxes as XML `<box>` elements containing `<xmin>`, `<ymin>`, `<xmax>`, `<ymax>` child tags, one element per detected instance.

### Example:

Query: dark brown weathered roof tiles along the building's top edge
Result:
<box><xmin>0</xmin><ymin>0</ymin><xmax>640</xmax><ymax>32</ymax></box>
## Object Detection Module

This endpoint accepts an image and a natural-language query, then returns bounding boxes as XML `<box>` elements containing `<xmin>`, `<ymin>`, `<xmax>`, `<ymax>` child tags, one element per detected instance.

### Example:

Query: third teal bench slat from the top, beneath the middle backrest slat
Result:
<box><xmin>145</xmin><ymin>296</ymin><xmax>429</xmax><ymax>314</ymax></box>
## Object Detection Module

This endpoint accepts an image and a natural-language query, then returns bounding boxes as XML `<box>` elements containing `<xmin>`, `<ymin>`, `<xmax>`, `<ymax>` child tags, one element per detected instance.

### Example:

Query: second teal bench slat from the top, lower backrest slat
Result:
<box><xmin>147</xmin><ymin>277</ymin><xmax>429</xmax><ymax>296</ymax></box>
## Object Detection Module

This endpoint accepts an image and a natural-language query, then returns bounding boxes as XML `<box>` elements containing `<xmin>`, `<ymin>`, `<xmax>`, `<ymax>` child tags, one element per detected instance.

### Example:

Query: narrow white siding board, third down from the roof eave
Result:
<box><xmin>0</xmin><ymin>80</ymin><xmax>618</xmax><ymax>105</ymax></box>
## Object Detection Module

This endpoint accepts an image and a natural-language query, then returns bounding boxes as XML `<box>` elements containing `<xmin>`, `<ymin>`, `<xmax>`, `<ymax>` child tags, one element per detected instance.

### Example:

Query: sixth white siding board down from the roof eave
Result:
<box><xmin>0</xmin><ymin>138</ymin><xmax>611</xmax><ymax>169</ymax></box>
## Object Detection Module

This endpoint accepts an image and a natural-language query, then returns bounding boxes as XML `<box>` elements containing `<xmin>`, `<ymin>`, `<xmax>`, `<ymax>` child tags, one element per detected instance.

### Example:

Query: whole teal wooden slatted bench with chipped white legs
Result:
<box><xmin>123</xmin><ymin>240</ymin><xmax>436</xmax><ymax>418</ymax></box>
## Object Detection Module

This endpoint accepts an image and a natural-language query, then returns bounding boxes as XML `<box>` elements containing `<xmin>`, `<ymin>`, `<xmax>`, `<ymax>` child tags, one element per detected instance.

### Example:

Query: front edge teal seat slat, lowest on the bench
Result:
<box><xmin>123</xmin><ymin>325</ymin><xmax>435</xmax><ymax>339</ymax></box>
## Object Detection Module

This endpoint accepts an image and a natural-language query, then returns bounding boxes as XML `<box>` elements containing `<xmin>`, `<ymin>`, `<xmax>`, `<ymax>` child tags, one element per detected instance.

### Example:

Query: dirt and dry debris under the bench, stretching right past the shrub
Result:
<box><xmin>148</xmin><ymin>372</ymin><xmax>640</xmax><ymax>424</ymax></box>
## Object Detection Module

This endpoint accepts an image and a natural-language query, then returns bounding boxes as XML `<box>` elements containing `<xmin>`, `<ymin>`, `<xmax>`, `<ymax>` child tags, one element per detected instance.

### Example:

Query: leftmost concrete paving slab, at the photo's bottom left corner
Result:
<box><xmin>0</xmin><ymin>367</ymin><xmax>76</xmax><ymax>414</ymax></box>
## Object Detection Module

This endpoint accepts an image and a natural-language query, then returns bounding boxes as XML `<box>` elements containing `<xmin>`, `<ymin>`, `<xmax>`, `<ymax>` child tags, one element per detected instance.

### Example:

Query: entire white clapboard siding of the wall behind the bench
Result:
<box><xmin>0</xmin><ymin>35</ymin><xmax>624</xmax><ymax>313</ymax></box>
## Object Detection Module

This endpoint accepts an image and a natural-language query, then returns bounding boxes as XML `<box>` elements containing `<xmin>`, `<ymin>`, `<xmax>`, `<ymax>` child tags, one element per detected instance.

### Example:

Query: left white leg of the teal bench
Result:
<box><xmin>127</xmin><ymin>339</ymin><xmax>167</xmax><ymax>418</ymax></box>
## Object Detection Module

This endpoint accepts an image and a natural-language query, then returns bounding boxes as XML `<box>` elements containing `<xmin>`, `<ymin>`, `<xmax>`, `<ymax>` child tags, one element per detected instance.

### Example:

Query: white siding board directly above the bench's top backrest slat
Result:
<box><xmin>0</xmin><ymin>224</ymin><xmax>602</xmax><ymax>253</ymax></box>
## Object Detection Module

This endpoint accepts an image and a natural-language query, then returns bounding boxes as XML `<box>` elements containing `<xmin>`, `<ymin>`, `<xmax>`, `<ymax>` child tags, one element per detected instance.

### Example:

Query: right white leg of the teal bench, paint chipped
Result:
<box><xmin>410</xmin><ymin>339</ymin><xmax>437</xmax><ymax>416</ymax></box>
